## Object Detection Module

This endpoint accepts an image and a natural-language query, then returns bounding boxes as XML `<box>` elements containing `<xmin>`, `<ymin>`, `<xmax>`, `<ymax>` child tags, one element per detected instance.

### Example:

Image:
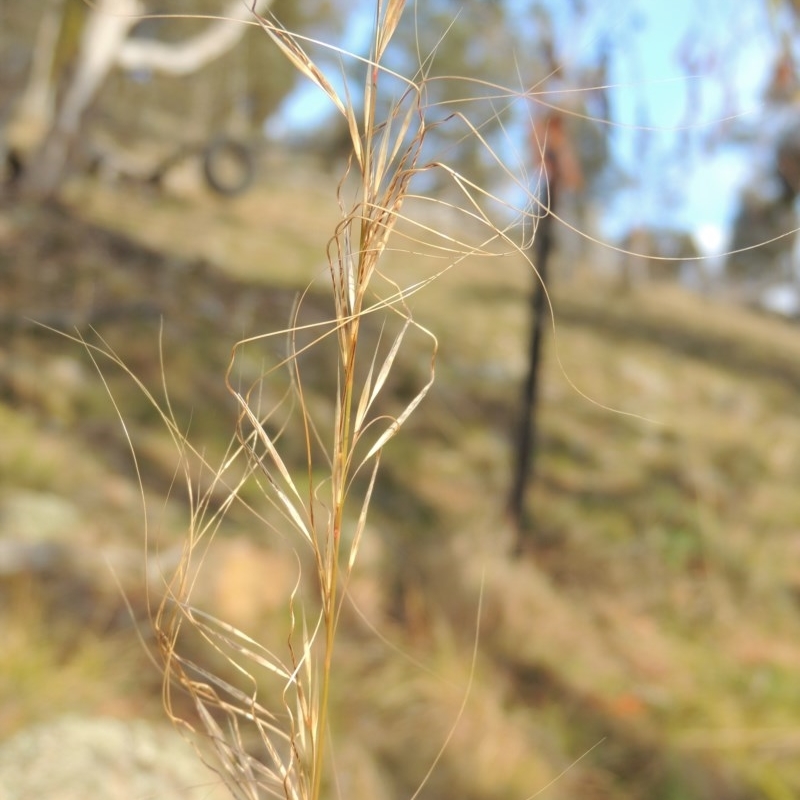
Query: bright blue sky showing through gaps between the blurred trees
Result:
<box><xmin>271</xmin><ymin>0</ymin><xmax>785</xmax><ymax>250</ymax></box>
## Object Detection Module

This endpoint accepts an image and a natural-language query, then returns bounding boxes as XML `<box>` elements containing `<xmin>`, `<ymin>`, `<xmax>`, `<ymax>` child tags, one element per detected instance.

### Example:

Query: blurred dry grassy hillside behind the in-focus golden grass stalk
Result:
<box><xmin>0</xmin><ymin>168</ymin><xmax>800</xmax><ymax>800</ymax></box>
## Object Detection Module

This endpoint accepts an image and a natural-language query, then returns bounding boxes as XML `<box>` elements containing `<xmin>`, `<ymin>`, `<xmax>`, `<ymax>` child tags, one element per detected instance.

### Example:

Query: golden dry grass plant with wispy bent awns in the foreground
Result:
<box><xmin>59</xmin><ymin>0</ymin><xmax>552</xmax><ymax>800</ymax></box>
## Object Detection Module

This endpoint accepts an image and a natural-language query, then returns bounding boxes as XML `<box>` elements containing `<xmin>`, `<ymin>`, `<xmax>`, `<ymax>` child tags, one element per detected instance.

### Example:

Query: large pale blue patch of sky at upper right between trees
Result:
<box><xmin>609</xmin><ymin>0</ymin><xmax>779</xmax><ymax>245</ymax></box>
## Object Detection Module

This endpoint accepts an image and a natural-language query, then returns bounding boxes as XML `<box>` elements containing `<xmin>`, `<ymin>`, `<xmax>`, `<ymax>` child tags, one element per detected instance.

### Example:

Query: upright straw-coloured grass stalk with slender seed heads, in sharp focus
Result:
<box><xmin>148</xmin><ymin>0</ymin><xmax>536</xmax><ymax>800</ymax></box>
